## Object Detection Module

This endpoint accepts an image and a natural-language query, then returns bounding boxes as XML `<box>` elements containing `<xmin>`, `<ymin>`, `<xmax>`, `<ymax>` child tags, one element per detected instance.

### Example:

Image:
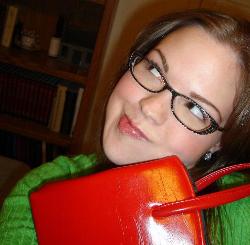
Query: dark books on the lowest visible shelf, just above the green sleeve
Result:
<box><xmin>0</xmin><ymin>131</ymin><xmax>65</xmax><ymax>168</ymax></box>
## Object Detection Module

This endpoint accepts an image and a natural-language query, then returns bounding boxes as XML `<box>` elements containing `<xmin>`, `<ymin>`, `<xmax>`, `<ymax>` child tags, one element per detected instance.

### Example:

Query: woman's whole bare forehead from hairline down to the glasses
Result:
<box><xmin>150</xmin><ymin>26</ymin><xmax>240</xmax><ymax>122</ymax></box>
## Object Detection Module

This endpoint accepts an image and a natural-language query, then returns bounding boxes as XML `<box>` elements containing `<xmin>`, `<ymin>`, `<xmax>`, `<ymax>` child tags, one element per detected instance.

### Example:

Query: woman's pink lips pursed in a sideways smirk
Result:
<box><xmin>118</xmin><ymin>115</ymin><xmax>148</xmax><ymax>140</ymax></box>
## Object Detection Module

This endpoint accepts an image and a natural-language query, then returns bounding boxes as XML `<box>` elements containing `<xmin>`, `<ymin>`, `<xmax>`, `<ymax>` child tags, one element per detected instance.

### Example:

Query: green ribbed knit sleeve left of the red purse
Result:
<box><xmin>0</xmin><ymin>155</ymin><xmax>96</xmax><ymax>245</ymax></box>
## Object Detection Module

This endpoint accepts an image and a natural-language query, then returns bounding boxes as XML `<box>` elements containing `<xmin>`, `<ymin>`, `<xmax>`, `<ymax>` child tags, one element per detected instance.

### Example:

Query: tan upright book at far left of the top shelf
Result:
<box><xmin>1</xmin><ymin>5</ymin><xmax>18</xmax><ymax>48</ymax></box>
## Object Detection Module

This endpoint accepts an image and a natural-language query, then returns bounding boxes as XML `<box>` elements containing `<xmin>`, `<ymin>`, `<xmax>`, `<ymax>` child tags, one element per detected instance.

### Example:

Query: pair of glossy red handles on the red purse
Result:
<box><xmin>152</xmin><ymin>163</ymin><xmax>250</xmax><ymax>218</ymax></box>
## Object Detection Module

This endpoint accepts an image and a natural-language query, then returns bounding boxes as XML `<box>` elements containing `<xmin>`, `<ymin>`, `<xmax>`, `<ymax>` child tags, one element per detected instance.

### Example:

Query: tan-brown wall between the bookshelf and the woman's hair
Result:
<box><xmin>101</xmin><ymin>0</ymin><xmax>200</xmax><ymax>81</ymax></box>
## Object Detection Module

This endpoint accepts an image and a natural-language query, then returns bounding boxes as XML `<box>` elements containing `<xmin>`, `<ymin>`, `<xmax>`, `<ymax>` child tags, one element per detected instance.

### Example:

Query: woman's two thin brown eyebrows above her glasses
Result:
<box><xmin>153</xmin><ymin>48</ymin><xmax>222</xmax><ymax>122</ymax></box>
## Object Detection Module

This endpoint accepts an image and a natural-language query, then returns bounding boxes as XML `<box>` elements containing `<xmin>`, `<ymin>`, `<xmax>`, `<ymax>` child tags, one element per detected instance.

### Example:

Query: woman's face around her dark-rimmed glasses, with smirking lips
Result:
<box><xmin>103</xmin><ymin>27</ymin><xmax>239</xmax><ymax>168</ymax></box>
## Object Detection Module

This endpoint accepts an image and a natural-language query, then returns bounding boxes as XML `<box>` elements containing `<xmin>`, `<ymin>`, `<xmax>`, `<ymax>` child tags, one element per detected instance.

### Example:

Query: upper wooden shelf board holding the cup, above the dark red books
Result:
<box><xmin>0</xmin><ymin>47</ymin><xmax>88</xmax><ymax>86</ymax></box>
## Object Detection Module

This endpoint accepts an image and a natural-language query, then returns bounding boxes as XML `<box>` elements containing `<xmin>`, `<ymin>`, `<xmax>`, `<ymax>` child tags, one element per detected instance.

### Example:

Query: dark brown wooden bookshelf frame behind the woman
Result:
<box><xmin>0</xmin><ymin>0</ymin><xmax>116</xmax><ymax>165</ymax></box>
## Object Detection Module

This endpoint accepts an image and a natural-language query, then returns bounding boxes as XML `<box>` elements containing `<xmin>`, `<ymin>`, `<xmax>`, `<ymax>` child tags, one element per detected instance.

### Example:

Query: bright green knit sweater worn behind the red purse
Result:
<box><xmin>0</xmin><ymin>155</ymin><xmax>250</xmax><ymax>245</ymax></box>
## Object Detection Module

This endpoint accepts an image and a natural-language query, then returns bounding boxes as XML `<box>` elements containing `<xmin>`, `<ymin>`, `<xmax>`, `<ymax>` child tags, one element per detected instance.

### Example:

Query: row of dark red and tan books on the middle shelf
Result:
<box><xmin>0</xmin><ymin>60</ymin><xmax>84</xmax><ymax>135</ymax></box>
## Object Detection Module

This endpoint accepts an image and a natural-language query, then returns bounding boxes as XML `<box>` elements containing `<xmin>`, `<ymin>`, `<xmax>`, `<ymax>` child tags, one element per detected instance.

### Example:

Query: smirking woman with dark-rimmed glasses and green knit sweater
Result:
<box><xmin>0</xmin><ymin>11</ymin><xmax>250</xmax><ymax>244</ymax></box>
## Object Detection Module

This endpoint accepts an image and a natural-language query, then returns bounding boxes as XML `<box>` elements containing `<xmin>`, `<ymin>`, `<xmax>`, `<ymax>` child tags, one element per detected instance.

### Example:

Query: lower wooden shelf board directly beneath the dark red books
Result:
<box><xmin>0</xmin><ymin>114</ymin><xmax>71</xmax><ymax>147</ymax></box>
